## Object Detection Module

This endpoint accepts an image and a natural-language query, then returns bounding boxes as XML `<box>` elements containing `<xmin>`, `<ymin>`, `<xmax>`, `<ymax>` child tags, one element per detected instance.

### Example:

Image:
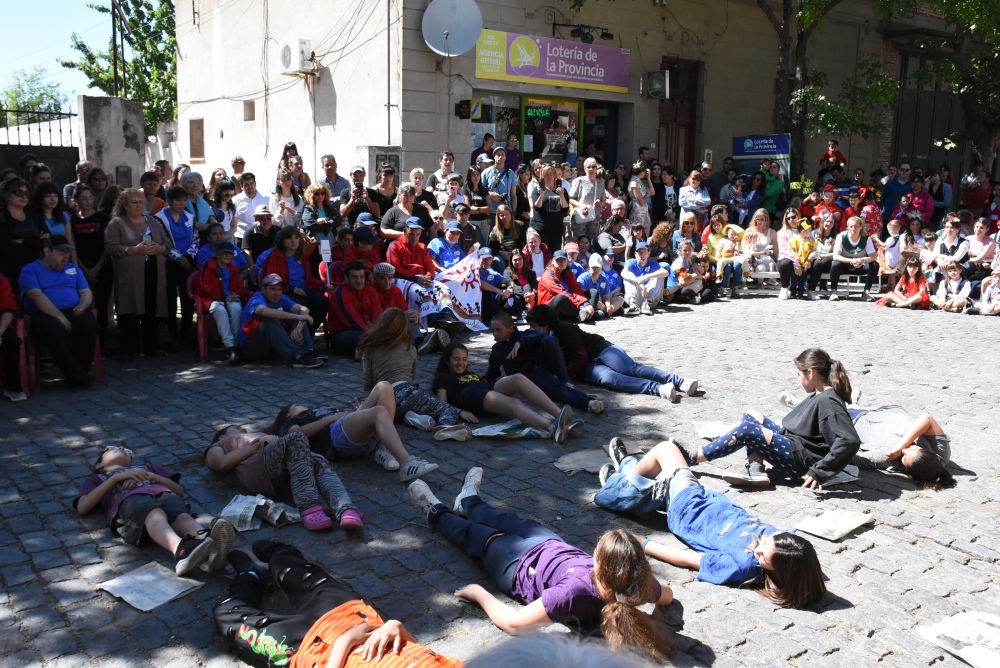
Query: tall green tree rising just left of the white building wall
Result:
<box><xmin>59</xmin><ymin>0</ymin><xmax>177</xmax><ymax>136</ymax></box>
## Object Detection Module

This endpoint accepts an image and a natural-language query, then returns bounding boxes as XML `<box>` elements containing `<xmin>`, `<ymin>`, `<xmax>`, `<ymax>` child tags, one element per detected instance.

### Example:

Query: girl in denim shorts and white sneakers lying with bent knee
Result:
<box><xmin>268</xmin><ymin>383</ymin><xmax>437</xmax><ymax>482</ymax></box>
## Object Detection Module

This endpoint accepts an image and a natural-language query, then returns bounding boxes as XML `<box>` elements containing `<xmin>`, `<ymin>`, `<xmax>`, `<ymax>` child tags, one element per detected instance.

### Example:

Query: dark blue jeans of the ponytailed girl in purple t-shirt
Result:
<box><xmin>430</xmin><ymin>496</ymin><xmax>561</xmax><ymax>595</ymax></box>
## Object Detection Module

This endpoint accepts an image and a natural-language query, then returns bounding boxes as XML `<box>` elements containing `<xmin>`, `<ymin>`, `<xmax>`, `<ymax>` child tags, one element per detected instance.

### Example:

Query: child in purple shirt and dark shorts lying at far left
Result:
<box><xmin>73</xmin><ymin>445</ymin><xmax>236</xmax><ymax>575</ymax></box>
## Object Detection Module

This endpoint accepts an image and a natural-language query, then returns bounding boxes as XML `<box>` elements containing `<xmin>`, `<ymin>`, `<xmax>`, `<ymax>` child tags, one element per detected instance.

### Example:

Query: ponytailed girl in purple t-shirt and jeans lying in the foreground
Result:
<box><xmin>409</xmin><ymin>467</ymin><xmax>673</xmax><ymax>661</ymax></box>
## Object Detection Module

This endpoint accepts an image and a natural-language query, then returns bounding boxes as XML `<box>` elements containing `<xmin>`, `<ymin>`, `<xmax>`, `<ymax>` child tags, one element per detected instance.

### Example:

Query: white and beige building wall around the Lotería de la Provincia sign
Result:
<box><xmin>171</xmin><ymin>0</ymin><xmax>900</xmax><ymax>183</ymax></box>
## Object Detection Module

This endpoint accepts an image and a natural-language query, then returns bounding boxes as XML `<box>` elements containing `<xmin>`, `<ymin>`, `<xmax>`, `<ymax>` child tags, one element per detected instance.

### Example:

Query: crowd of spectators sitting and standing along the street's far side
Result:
<box><xmin>0</xmin><ymin>141</ymin><xmax>1000</xmax><ymax>400</ymax></box>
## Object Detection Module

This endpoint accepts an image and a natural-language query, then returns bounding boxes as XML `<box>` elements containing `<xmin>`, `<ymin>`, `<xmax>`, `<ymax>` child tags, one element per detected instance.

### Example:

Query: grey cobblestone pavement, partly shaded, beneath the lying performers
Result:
<box><xmin>0</xmin><ymin>293</ymin><xmax>1000</xmax><ymax>668</ymax></box>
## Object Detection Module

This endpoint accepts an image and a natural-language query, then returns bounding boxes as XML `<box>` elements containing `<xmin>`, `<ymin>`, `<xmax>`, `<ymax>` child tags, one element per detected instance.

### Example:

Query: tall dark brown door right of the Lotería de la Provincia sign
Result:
<box><xmin>657</xmin><ymin>58</ymin><xmax>701</xmax><ymax>175</ymax></box>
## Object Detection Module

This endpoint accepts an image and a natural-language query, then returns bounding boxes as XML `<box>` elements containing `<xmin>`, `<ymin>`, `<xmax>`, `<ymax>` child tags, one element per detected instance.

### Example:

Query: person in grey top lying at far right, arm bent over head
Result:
<box><xmin>850</xmin><ymin>406</ymin><xmax>955</xmax><ymax>491</ymax></box>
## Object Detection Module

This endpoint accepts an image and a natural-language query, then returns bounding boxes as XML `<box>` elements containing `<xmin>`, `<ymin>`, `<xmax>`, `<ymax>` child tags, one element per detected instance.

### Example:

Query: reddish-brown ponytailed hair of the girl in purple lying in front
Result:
<box><xmin>594</xmin><ymin>529</ymin><xmax>674</xmax><ymax>661</ymax></box>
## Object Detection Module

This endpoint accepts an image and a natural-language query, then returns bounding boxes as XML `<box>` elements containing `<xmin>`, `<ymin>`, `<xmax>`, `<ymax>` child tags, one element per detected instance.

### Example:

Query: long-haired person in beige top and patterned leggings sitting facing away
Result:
<box><xmin>357</xmin><ymin>308</ymin><xmax>472</xmax><ymax>441</ymax></box>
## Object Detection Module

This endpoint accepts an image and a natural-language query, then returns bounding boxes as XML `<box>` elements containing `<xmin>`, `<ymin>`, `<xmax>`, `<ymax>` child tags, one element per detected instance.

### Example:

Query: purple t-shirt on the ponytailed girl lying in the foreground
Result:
<box><xmin>511</xmin><ymin>538</ymin><xmax>604</xmax><ymax>622</ymax></box>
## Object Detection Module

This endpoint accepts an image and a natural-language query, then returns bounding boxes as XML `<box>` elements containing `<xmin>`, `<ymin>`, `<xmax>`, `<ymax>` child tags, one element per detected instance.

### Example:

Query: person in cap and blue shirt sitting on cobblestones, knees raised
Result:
<box><xmin>236</xmin><ymin>274</ymin><xmax>326</xmax><ymax>369</ymax></box>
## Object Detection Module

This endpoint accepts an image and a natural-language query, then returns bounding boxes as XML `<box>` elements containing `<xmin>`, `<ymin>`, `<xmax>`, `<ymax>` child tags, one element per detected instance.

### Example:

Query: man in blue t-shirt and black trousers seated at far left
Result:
<box><xmin>19</xmin><ymin>236</ymin><xmax>97</xmax><ymax>389</ymax></box>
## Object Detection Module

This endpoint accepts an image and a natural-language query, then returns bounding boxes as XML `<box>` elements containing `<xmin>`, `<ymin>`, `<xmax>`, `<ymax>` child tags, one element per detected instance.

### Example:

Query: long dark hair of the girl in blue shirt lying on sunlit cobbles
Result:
<box><xmin>747</xmin><ymin>532</ymin><xmax>826</xmax><ymax>610</ymax></box>
